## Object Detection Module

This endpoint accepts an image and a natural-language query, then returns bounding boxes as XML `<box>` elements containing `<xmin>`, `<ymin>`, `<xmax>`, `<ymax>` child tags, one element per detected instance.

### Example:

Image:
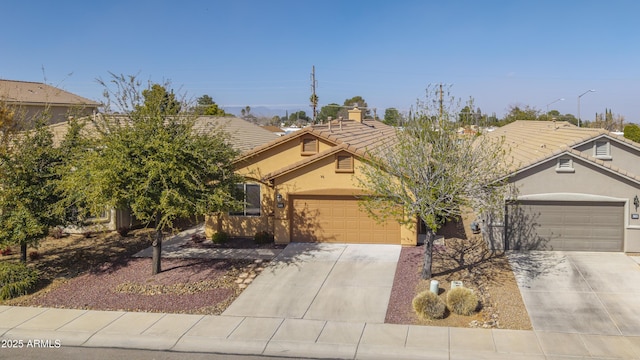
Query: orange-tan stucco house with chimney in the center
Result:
<box><xmin>206</xmin><ymin>108</ymin><xmax>417</xmax><ymax>245</ymax></box>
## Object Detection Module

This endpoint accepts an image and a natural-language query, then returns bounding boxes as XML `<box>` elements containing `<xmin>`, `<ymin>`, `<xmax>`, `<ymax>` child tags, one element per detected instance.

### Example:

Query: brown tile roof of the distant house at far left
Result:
<box><xmin>0</xmin><ymin>80</ymin><xmax>100</xmax><ymax>107</ymax></box>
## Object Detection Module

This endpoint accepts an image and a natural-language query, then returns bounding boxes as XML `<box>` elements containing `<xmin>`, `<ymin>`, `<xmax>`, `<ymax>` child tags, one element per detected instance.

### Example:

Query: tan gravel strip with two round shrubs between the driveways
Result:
<box><xmin>385</xmin><ymin>226</ymin><xmax>531</xmax><ymax>330</ymax></box>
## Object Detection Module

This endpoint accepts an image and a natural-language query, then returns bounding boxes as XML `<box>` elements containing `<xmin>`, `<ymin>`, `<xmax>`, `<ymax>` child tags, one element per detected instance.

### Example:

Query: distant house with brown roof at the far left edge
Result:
<box><xmin>0</xmin><ymin>80</ymin><xmax>101</xmax><ymax>128</ymax></box>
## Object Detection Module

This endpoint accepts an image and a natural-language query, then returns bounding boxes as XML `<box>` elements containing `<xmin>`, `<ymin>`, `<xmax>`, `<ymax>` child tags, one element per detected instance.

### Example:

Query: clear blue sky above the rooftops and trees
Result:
<box><xmin>0</xmin><ymin>0</ymin><xmax>640</xmax><ymax>123</ymax></box>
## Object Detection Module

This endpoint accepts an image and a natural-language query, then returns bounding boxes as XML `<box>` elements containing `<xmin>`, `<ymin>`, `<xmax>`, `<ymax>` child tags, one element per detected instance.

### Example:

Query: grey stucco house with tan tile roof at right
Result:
<box><xmin>485</xmin><ymin>121</ymin><xmax>640</xmax><ymax>252</ymax></box>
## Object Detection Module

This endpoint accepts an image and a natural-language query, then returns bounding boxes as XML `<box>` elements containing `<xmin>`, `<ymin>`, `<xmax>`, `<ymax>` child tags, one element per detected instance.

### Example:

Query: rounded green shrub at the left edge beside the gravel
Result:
<box><xmin>0</xmin><ymin>261</ymin><xmax>38</xmax><ymax>300</ymax></box>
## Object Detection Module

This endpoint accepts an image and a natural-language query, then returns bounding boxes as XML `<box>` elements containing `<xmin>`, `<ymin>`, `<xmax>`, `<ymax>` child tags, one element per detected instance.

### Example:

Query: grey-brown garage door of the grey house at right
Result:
<box><xmin>506</xmin><ymin>201</ymin><xmax>624</xmax><ymax>251</ymax></box>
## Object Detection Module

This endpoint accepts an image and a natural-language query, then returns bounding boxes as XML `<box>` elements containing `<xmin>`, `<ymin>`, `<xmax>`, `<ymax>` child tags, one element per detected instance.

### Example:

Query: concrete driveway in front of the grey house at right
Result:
<box><xmin>508</xmin><ymin>251</ymin><xmax>640</xmax><ymax>336</ymax></box>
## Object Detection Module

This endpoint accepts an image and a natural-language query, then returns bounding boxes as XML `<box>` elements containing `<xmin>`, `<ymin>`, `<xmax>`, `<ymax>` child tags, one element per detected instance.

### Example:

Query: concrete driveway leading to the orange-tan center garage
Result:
<box><xmin>222</xmin><ymin>243</ymin><xmax>401</xmax><ymax>323</ymax></box>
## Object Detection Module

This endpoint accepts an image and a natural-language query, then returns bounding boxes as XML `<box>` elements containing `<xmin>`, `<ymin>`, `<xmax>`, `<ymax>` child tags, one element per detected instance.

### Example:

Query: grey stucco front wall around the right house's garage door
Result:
<box><xmin>511</xmin><ymin>157</ymin><xmax>640</xmax><ymax>252</ymax></box>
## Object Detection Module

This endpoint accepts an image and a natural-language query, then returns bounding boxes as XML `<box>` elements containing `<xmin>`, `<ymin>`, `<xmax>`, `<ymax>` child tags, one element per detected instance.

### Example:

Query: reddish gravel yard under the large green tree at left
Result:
<box><xmin>22</xmin><ymin>258</ymin><xmax>253</xmax><ymax>315</ymax></box>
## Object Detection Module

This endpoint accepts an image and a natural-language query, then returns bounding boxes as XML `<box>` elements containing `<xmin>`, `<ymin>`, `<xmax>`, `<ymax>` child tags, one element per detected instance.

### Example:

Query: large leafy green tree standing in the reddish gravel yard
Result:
<box><xmin>60</xmin><ymin>74</ymin><xmax>241</xmax><ymax>274</ymax></box>
